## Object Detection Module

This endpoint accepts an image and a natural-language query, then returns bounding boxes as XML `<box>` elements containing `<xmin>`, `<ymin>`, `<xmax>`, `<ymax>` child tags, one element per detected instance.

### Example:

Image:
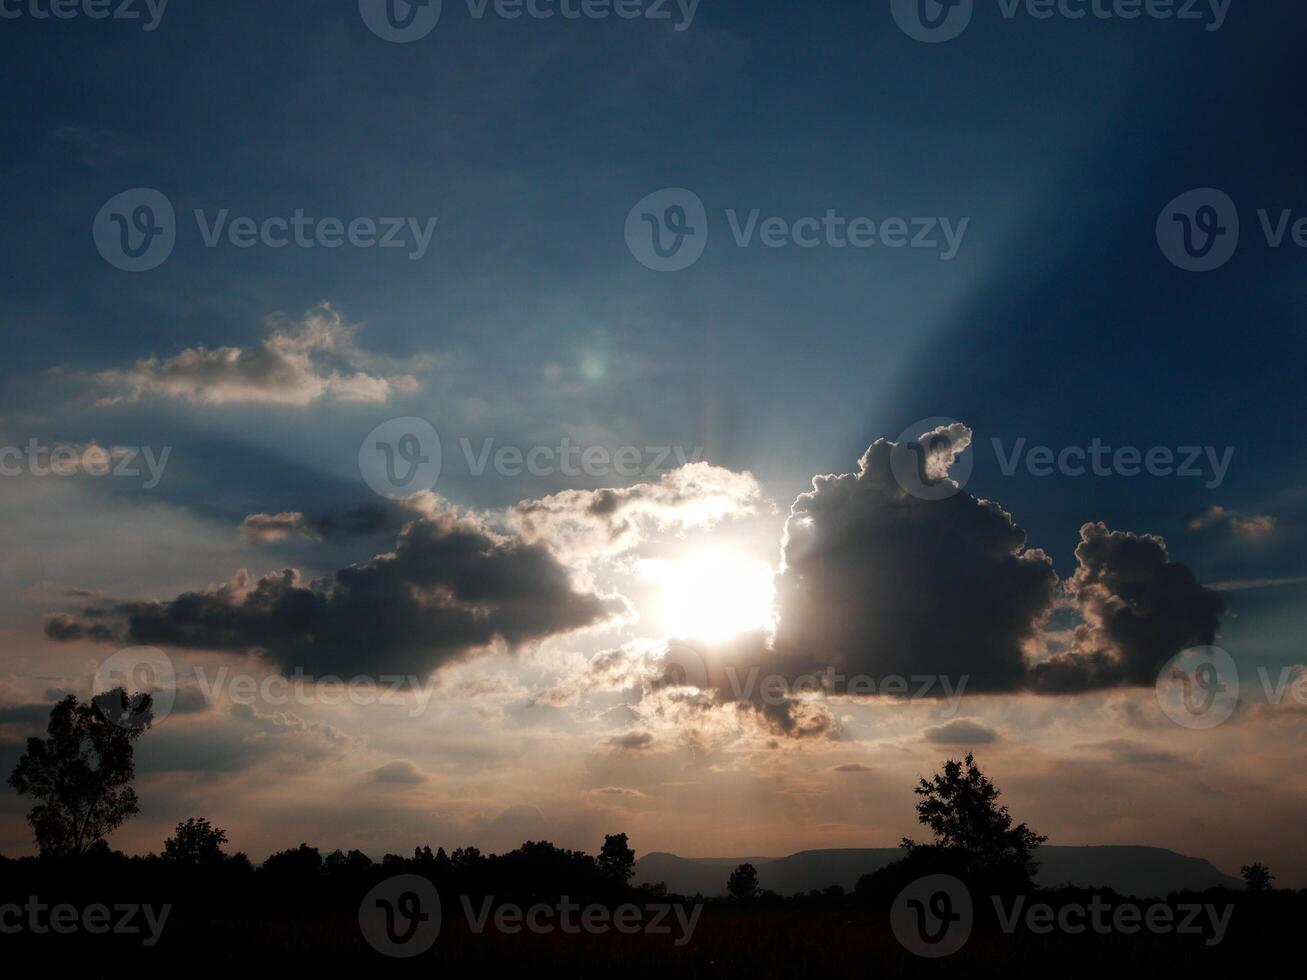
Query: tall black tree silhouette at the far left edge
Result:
<box><xmin>9</xmin><ymin>687</ymin><xmax>154</xmax><ymax>857</ymax></box>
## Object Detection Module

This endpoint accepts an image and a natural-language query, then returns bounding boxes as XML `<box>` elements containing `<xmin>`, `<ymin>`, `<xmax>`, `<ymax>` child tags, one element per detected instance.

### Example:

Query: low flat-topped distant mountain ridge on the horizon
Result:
<box><xmin>635</xmin><ymin>845</ymin><xmax>1243</xmax><ymax>896</ymax></box>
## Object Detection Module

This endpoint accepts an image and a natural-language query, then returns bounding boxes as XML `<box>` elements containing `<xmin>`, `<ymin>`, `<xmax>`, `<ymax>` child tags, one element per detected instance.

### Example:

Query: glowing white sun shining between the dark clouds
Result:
<box><xmin>639</xmin><ymin>550</ymin><xmax>775</xmax><ymax>642</ymax></box>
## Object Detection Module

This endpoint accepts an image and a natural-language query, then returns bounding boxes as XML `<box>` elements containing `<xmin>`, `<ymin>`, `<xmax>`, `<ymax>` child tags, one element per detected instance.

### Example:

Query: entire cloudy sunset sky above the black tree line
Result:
<box><xmin>0</xmin><ymin>0</ymin><xmax>1307</xmax><ymax>886</ymax></box>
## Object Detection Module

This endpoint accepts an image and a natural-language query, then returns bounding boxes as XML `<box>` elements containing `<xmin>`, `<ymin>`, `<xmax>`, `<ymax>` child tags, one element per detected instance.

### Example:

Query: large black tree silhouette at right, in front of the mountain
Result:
<box><xmin>903</xmin><ymin>753</ymin><xmax>1048</xmax><ymax>874</ymax></box>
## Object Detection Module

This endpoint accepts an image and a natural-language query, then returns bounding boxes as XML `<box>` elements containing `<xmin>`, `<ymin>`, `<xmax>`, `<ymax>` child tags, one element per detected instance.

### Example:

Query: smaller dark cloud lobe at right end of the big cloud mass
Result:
<box><xmin>1030</xmin><ymin>524</ymin><xmax>1226</xmax><ymax>693</ymax></box>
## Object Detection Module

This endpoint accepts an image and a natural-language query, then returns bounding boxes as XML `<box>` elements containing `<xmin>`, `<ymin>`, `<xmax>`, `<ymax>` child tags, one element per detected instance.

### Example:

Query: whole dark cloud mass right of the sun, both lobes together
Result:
<box><xmin>632</xmin><ymin>430</ymin><xmax>1226</xmax><ymax>738</ymax></box>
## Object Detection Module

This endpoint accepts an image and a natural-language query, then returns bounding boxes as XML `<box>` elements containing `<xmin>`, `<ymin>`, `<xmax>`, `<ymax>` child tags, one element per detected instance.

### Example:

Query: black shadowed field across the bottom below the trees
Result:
<box><xmin>0</xmin><ymin>861</ymin><xmax>1303</xmax><ymax>980</ymax></box>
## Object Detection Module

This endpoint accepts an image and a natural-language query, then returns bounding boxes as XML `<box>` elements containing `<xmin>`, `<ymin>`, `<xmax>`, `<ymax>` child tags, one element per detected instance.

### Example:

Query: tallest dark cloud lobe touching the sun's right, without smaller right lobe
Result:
<box><xmin>775</xmin><ymin>439</ymin><xmax>1057</xmax><ymax>691</ymax></box>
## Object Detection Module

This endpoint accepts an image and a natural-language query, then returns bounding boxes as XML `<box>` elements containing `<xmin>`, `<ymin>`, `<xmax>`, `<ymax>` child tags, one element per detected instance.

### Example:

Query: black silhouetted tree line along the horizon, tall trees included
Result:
<box><xmin>0</xmin><ymin>687</ymin><xmax>1274</xmax><ymax>903</ymax></box>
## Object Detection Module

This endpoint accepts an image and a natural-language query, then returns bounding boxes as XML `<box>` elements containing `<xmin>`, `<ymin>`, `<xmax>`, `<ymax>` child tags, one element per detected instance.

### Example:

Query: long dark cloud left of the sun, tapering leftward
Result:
<box><xmin>46</xmin><ymin>499</ymin><xmax>617</xmax><ymax>677</ymax></box>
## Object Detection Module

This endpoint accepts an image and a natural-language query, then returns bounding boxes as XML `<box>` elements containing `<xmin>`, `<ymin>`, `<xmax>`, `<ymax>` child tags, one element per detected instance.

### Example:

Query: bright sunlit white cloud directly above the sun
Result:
<box><xmin>508</xmin><ymin>463</ymin><xmax>771</xmax><ymax>557</ymax></box>
